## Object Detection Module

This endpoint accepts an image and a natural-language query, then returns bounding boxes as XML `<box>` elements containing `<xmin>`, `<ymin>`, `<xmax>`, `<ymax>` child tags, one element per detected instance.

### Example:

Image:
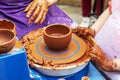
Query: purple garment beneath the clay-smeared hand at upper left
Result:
<box><xmin>0</xmin><ymin>0</ymin><xmax>72</xmax><ymax>38</ymax></box>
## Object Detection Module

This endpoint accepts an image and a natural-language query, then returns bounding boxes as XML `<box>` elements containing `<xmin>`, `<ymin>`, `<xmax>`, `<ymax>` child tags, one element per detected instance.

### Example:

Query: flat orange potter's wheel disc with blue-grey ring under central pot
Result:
<box><xmin>30</xmin><ymin>34</ymin><xmax>86</xmax><ymax>64</ymax></box>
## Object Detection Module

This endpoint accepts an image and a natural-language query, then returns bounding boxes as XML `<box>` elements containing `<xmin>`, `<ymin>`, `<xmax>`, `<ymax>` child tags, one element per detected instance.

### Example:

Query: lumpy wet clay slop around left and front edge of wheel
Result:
<box><xmin>21</xmin><ymin>29</ymin><xmax>90</xmax><ymax>68</ymax></box>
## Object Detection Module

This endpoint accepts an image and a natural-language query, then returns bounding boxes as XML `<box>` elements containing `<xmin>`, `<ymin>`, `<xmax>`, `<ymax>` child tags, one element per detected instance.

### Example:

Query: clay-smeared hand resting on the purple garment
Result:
<box><xmin>24</xmin><ymin>0</ymin><xmax>48</xmax><ymax>24</ymax></box>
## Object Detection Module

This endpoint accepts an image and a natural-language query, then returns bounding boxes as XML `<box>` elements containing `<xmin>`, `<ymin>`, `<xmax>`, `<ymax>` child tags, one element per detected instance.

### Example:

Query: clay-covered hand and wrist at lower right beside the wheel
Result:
<box><xmin>89</xmin><ymin>45</ymin><xmax>117</xmax><ymax>71</ymax></box>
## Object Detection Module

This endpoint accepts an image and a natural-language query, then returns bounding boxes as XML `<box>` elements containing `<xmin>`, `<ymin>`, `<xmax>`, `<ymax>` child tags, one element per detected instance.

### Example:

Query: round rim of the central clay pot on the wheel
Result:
<box><xmin>43</xmin><ymin>24</ymin><xmax>72</xmax><ymax>38</ymax></box>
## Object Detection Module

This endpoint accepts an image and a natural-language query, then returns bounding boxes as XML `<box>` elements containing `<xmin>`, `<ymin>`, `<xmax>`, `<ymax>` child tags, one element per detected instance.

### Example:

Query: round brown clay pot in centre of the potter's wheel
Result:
<box><xmin>43</xmin><ymin>24</ymin><xmax>72</xmax><ymax>50</ymax></box>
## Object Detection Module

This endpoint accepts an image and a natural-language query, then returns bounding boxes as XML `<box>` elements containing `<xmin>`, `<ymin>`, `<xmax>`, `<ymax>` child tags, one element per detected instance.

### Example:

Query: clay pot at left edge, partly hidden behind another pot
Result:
<box><xmin>0</xmin><ymin>19</ymin><xmax>16</xmax><ymax>34</ymax></box>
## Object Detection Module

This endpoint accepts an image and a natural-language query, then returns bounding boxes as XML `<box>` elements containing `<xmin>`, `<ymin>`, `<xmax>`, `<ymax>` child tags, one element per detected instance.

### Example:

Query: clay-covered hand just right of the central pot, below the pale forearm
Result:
<box><xmin>73</xmin><ymin>26</ymin><xmax>95</xmax><ymax>37</ymax></box>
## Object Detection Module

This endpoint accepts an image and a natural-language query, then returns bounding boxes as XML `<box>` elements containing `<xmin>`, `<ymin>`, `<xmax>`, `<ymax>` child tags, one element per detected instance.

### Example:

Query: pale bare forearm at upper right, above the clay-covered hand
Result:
<box><xmin>91</xmin><ymin>8</ymin><xmax>111</xmax><ymax>33</ymax></box>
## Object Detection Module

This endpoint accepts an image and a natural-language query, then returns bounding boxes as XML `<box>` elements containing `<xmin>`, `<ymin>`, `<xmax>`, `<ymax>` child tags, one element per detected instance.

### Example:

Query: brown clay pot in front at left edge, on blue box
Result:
<box><xmin>0</xmin><ymin>29</ymin><xmax>16</xmax><ymax>54</ymax></box>
